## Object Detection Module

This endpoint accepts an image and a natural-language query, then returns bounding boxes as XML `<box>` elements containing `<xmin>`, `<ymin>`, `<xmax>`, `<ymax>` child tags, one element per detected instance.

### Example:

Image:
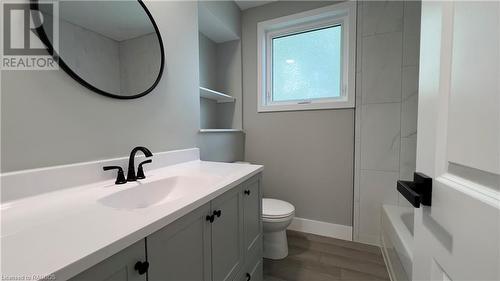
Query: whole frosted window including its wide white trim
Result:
<box><xmin>258</xmin><ymin>2</ymin><xmax>356</xmax><ymax>112</ymax></box>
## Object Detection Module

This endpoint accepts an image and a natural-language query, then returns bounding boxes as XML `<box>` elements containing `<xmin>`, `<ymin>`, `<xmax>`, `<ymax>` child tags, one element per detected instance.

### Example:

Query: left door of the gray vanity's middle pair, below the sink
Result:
<box><xmin>146</xmin><ymin>203</ymin><xmax>211</xmax><ymax>281</ymax></box>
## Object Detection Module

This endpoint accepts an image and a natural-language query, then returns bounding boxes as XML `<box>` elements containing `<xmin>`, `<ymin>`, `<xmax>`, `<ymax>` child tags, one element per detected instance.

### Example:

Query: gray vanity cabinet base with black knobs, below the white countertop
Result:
<box><xmin>67</xmin><ymin>175</ymin><xmax>262</xmax><ymax>281</ymax></box>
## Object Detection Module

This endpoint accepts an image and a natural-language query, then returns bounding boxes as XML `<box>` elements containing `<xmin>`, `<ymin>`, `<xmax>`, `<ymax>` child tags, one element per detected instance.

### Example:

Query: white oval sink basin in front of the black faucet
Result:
<box><xmin>98</xmin><ymin>176</ymin><xmax>217</xmax><ymax>209</ymax></box>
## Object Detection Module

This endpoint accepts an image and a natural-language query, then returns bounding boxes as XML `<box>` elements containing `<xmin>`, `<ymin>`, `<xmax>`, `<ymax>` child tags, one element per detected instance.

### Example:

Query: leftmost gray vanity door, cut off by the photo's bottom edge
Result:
<box><xmin>70</xmin><ymin>239</ymin><xmax>146</xmax><ymax>281</ymax></box>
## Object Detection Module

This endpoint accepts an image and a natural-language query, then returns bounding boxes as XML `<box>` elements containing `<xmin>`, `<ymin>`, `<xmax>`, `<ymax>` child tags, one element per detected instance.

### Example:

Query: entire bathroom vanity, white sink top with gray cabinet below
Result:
<box><xmin>1</xmin><ymin>149</ymin><xmax>263</xmax><ymax>281</ymax></box>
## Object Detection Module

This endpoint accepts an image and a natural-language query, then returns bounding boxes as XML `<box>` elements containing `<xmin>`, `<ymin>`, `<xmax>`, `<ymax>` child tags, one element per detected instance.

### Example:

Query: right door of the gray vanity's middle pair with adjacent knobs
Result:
<box><xmin>212</xmin><ymin>186</ymin><xmax>243</xmax><ymax>281</ymax></box>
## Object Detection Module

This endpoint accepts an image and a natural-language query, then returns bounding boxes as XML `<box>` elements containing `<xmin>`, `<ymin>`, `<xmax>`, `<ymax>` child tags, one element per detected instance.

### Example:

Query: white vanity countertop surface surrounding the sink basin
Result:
<box><xmin>1</xmin><ymin>160</ymin><xmax>263</xmax><ymax>280</ymax></box>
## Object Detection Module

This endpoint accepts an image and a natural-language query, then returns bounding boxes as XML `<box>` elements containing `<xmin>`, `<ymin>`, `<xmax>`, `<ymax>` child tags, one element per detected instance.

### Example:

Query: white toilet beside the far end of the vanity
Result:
<box><xmin>262</xmin><ymin>198</ymin><xmax>295</xmax><ymax>260</ymax></box>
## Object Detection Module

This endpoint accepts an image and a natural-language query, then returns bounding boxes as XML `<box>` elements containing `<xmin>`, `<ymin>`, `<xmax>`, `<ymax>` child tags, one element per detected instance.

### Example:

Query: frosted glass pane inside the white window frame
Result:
<box><xmin>270</xmin><ymin>25</ymin><xmax>342</xmax><ymax>102</ymax></box>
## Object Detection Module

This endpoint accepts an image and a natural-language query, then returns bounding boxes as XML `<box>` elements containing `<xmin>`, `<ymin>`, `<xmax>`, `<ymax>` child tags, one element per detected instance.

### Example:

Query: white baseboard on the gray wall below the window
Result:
<box><xmin>288</xmin><ymin>215</ymin><xmax>352</xmax><ymax>241</ymax></box>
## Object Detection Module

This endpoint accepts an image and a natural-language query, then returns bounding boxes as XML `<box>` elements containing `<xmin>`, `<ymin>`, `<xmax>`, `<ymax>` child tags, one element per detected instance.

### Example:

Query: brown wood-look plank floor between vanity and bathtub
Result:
<box><xmin>264</xmin><ymin>231</ymin><xmax>389</xmax><ymax>281</ymax></box>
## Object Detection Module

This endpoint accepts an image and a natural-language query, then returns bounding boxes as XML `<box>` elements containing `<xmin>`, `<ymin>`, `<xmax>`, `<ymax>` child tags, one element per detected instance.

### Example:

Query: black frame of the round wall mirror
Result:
<box><xmin>30</xmin><ymin>0</ymin><xmax>165</xmax><ymax>100</ymax></box>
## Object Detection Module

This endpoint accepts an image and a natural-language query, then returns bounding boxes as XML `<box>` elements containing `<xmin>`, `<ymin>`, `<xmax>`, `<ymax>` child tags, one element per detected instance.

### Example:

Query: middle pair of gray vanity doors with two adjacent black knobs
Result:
<box><xmin>146</xmin><ymin>186</ymin><xmax>244</xmax><ymax>281</ymax></box>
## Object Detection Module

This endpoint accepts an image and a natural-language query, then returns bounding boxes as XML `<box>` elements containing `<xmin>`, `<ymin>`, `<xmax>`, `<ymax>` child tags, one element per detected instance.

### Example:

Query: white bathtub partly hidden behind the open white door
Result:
<box><xmin>380</xmin><ymin>205</ymin><xmax>413</xmax><ymax>281</ymax></box>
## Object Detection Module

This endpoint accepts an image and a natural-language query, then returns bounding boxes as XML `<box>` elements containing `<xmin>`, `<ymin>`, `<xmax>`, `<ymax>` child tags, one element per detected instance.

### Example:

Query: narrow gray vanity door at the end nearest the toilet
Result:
<box><xmin>242</xmin><ymin>175</ymin><xmax>262</xmax><ymax>257</ymax></box>
